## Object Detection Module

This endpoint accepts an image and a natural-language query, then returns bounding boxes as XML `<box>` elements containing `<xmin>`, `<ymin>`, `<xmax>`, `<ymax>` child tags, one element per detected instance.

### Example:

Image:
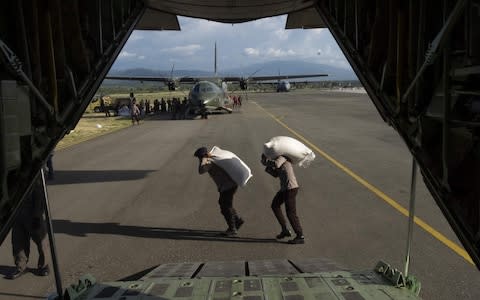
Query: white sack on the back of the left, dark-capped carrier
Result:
<box><xmin>210</xmin><ymin>146</ymin><xmax>253</xmax><ymax>187</ymax></box>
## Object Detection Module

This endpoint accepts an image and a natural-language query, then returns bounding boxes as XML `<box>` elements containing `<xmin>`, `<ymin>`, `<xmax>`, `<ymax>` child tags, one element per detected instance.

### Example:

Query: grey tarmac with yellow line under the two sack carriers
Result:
<box><xmin>0</xmin><ymin>91</ymin><xmax>480</xmax><ymax>299</ymax></box>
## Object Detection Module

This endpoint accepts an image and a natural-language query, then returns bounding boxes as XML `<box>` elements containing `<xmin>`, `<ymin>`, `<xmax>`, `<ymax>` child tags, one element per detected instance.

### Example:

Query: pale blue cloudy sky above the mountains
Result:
<box><xmin>113</xmin><ymin>15</ymin><xmax>350</xmax><ymax>72</ymax></box>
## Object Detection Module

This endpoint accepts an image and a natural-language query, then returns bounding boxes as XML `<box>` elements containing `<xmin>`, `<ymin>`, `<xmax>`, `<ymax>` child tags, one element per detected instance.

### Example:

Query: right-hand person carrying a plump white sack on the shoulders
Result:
<box><xmin>261</xmin><ymin>154</ymin><xmax>305</xmax><ymax>244</ymax></box>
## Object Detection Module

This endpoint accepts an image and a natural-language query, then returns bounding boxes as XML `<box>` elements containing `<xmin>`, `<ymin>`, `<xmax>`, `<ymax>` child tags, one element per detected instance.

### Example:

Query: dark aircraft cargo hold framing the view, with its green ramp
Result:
<box><xmin>0</xmin><ymin>0</ymin><xmax>480</xmax><ymax>299</ymax></box>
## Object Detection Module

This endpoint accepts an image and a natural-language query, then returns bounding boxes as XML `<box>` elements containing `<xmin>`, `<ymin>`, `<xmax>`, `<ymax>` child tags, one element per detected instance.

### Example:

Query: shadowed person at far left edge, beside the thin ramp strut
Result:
<box><xmin>6</xmin><ymin>176</ymin><xmax>50</xmax><ymax>279</ymax></box>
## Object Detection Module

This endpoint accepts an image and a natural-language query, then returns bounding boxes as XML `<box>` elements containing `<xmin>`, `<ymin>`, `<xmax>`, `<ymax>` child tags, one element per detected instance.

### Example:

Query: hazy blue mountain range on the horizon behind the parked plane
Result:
<box><xmin>109</xmin><ymin>60</ymin><xmax>357</xmax><ymax>81</ymax></box>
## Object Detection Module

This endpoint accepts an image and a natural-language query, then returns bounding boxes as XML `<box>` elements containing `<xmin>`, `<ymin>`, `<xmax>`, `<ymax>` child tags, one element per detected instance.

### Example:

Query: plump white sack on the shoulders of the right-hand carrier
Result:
<box><xmin>263</xmin><ymin>136</ymin><xmax>315</xmax><ymax>168</ymax></box>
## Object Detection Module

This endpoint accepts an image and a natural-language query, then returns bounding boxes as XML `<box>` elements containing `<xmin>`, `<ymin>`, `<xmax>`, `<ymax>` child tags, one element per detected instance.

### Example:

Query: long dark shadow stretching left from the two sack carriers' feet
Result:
<box><xmin>53</xmin><ymin>220</ymin><xmax>277</xmax><ymax>243</ymax></box>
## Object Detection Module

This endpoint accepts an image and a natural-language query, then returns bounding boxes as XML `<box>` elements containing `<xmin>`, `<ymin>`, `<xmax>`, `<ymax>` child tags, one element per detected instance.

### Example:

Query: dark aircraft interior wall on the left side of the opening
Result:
<box><xmin>0</xmin><ymin>0</ymin><xmax>144</xmax><ymax>241</ymax></box>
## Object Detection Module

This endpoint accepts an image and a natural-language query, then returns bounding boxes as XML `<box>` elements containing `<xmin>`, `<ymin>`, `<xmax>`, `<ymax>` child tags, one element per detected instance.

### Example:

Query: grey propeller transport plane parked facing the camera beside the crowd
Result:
<box><xmin>105</xmin><ymin>42</ymin><xmax>328</xmax><ymax>115</ymax></box>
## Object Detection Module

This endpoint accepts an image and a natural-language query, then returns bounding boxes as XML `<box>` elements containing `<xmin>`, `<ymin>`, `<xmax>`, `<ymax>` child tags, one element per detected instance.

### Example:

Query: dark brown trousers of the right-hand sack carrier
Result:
<box><xmin>272</xmin><ymin>188</ymin><xmax>303</xmax><ymax>236</ymax></box>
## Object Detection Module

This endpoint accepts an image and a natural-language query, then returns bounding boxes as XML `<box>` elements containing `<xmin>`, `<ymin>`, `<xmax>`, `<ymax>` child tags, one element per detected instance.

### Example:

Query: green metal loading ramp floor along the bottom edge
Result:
<box><xmin>82</xmin><ymin>271</ymin><xmax>420</xmax><ymax>300</ymax></box>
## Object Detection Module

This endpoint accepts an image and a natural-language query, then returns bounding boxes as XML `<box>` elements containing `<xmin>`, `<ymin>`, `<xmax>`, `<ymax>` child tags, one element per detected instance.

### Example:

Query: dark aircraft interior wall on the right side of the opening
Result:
<box><xmin>317</xmin><ymin>0</ymin><xmax>480</xmax><ymax>267</ymax></box>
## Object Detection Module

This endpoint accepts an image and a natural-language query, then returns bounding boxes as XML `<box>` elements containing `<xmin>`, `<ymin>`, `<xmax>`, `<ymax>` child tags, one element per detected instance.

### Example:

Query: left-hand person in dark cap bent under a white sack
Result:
<box><xmin>193</xmin><ymin>147</ymin><xmax>244</xmax><ymax>236</ymax></box>
